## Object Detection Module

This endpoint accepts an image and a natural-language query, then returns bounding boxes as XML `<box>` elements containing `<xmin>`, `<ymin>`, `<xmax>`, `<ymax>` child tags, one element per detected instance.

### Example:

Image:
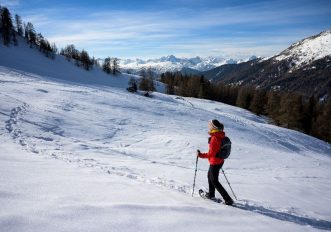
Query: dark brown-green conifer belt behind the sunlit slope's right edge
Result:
<box><xmin>160</xmin><ymin>72</ymin><xmax>331</xmax><ymax>142</ymax></box>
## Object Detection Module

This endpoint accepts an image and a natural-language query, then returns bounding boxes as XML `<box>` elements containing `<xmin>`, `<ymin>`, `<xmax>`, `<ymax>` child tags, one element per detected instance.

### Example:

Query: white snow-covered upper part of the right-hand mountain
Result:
<box><xmin>272</xmin><ymin>30</ymin><xmax>331</xmax><ymax>69</ymax></box>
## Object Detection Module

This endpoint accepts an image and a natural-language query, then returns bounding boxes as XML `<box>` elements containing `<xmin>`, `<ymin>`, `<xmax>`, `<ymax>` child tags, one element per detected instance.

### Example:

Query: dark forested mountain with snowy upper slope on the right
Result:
<box><xmin>200</xmin><ymin>30</ymin><xmax>331</xmax><ymax>97</ymax></box>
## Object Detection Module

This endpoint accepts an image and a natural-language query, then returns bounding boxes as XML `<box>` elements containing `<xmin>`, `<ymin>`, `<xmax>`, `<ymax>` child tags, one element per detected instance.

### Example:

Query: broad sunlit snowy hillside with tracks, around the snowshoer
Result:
<box><xmin>0</xmin><ymin>59</ymin><xmax>331</xmax><ymax>232</ymax></box>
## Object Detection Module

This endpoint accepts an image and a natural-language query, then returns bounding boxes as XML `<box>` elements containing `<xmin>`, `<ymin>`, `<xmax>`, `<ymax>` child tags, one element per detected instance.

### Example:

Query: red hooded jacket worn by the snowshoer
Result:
<box><xmin>199</xmin><ymin>131</ymin><xmax>225</xmax><ymax>165</ymax></box>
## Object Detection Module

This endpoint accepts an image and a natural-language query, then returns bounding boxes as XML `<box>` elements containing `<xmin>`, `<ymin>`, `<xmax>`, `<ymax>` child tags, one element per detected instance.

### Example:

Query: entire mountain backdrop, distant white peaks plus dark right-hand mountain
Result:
<box><xmin>120</xmin><ymin>30</ymin><xmax>331</xmax><ymax>98</ymax></box>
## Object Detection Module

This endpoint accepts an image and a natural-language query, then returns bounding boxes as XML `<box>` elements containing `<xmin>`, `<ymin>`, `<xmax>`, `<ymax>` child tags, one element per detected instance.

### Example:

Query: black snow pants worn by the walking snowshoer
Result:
<box><xmin>208</xmin><ymin>163</ymin><xmax>232</xmax><ymax>201</ymax></box>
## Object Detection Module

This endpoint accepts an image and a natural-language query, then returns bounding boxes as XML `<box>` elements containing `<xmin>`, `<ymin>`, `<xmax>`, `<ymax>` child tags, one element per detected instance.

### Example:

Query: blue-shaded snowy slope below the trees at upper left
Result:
<box><xmin>0</xmin><ymin>38</ymin><xmax>164</xmax><ymax>92</ymax></box>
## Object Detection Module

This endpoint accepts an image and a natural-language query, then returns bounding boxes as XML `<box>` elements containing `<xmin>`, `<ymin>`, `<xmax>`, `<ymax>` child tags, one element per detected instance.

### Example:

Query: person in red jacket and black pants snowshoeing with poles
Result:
<box><xmin>197</xmin><ymin>119</ymin><xmax>233</xmax><ymax>205</ymax></box>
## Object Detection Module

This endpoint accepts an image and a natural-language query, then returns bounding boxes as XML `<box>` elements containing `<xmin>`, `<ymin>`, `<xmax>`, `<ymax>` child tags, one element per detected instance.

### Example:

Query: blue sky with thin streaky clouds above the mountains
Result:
<box><xmin>0</xmin><ymin>0</ymin><xmax>331</xmax><ymax>59</ymax></box>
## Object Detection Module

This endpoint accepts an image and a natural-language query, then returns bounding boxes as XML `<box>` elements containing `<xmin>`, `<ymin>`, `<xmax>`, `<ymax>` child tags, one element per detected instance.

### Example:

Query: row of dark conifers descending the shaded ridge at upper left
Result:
<box><xmin>0</xmin><ymin>6</ymin><xmax>120</xmax><ymax>75</ymax></box>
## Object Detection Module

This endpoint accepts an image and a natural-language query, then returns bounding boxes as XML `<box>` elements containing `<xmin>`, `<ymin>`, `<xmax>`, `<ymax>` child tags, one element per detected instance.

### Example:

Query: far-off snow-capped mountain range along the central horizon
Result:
<box><xmin>120</xmin><ymin>55</ymin><xmax>257</xmax><ymax>74</ymax></box>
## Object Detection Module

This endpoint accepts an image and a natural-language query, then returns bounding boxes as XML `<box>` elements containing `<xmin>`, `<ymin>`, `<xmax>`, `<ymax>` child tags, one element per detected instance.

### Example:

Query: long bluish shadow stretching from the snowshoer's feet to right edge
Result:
<box><xmin>234</xmin><ymin>203</ymin><xmax>331</xmax><ymax>230</ymax></box>
